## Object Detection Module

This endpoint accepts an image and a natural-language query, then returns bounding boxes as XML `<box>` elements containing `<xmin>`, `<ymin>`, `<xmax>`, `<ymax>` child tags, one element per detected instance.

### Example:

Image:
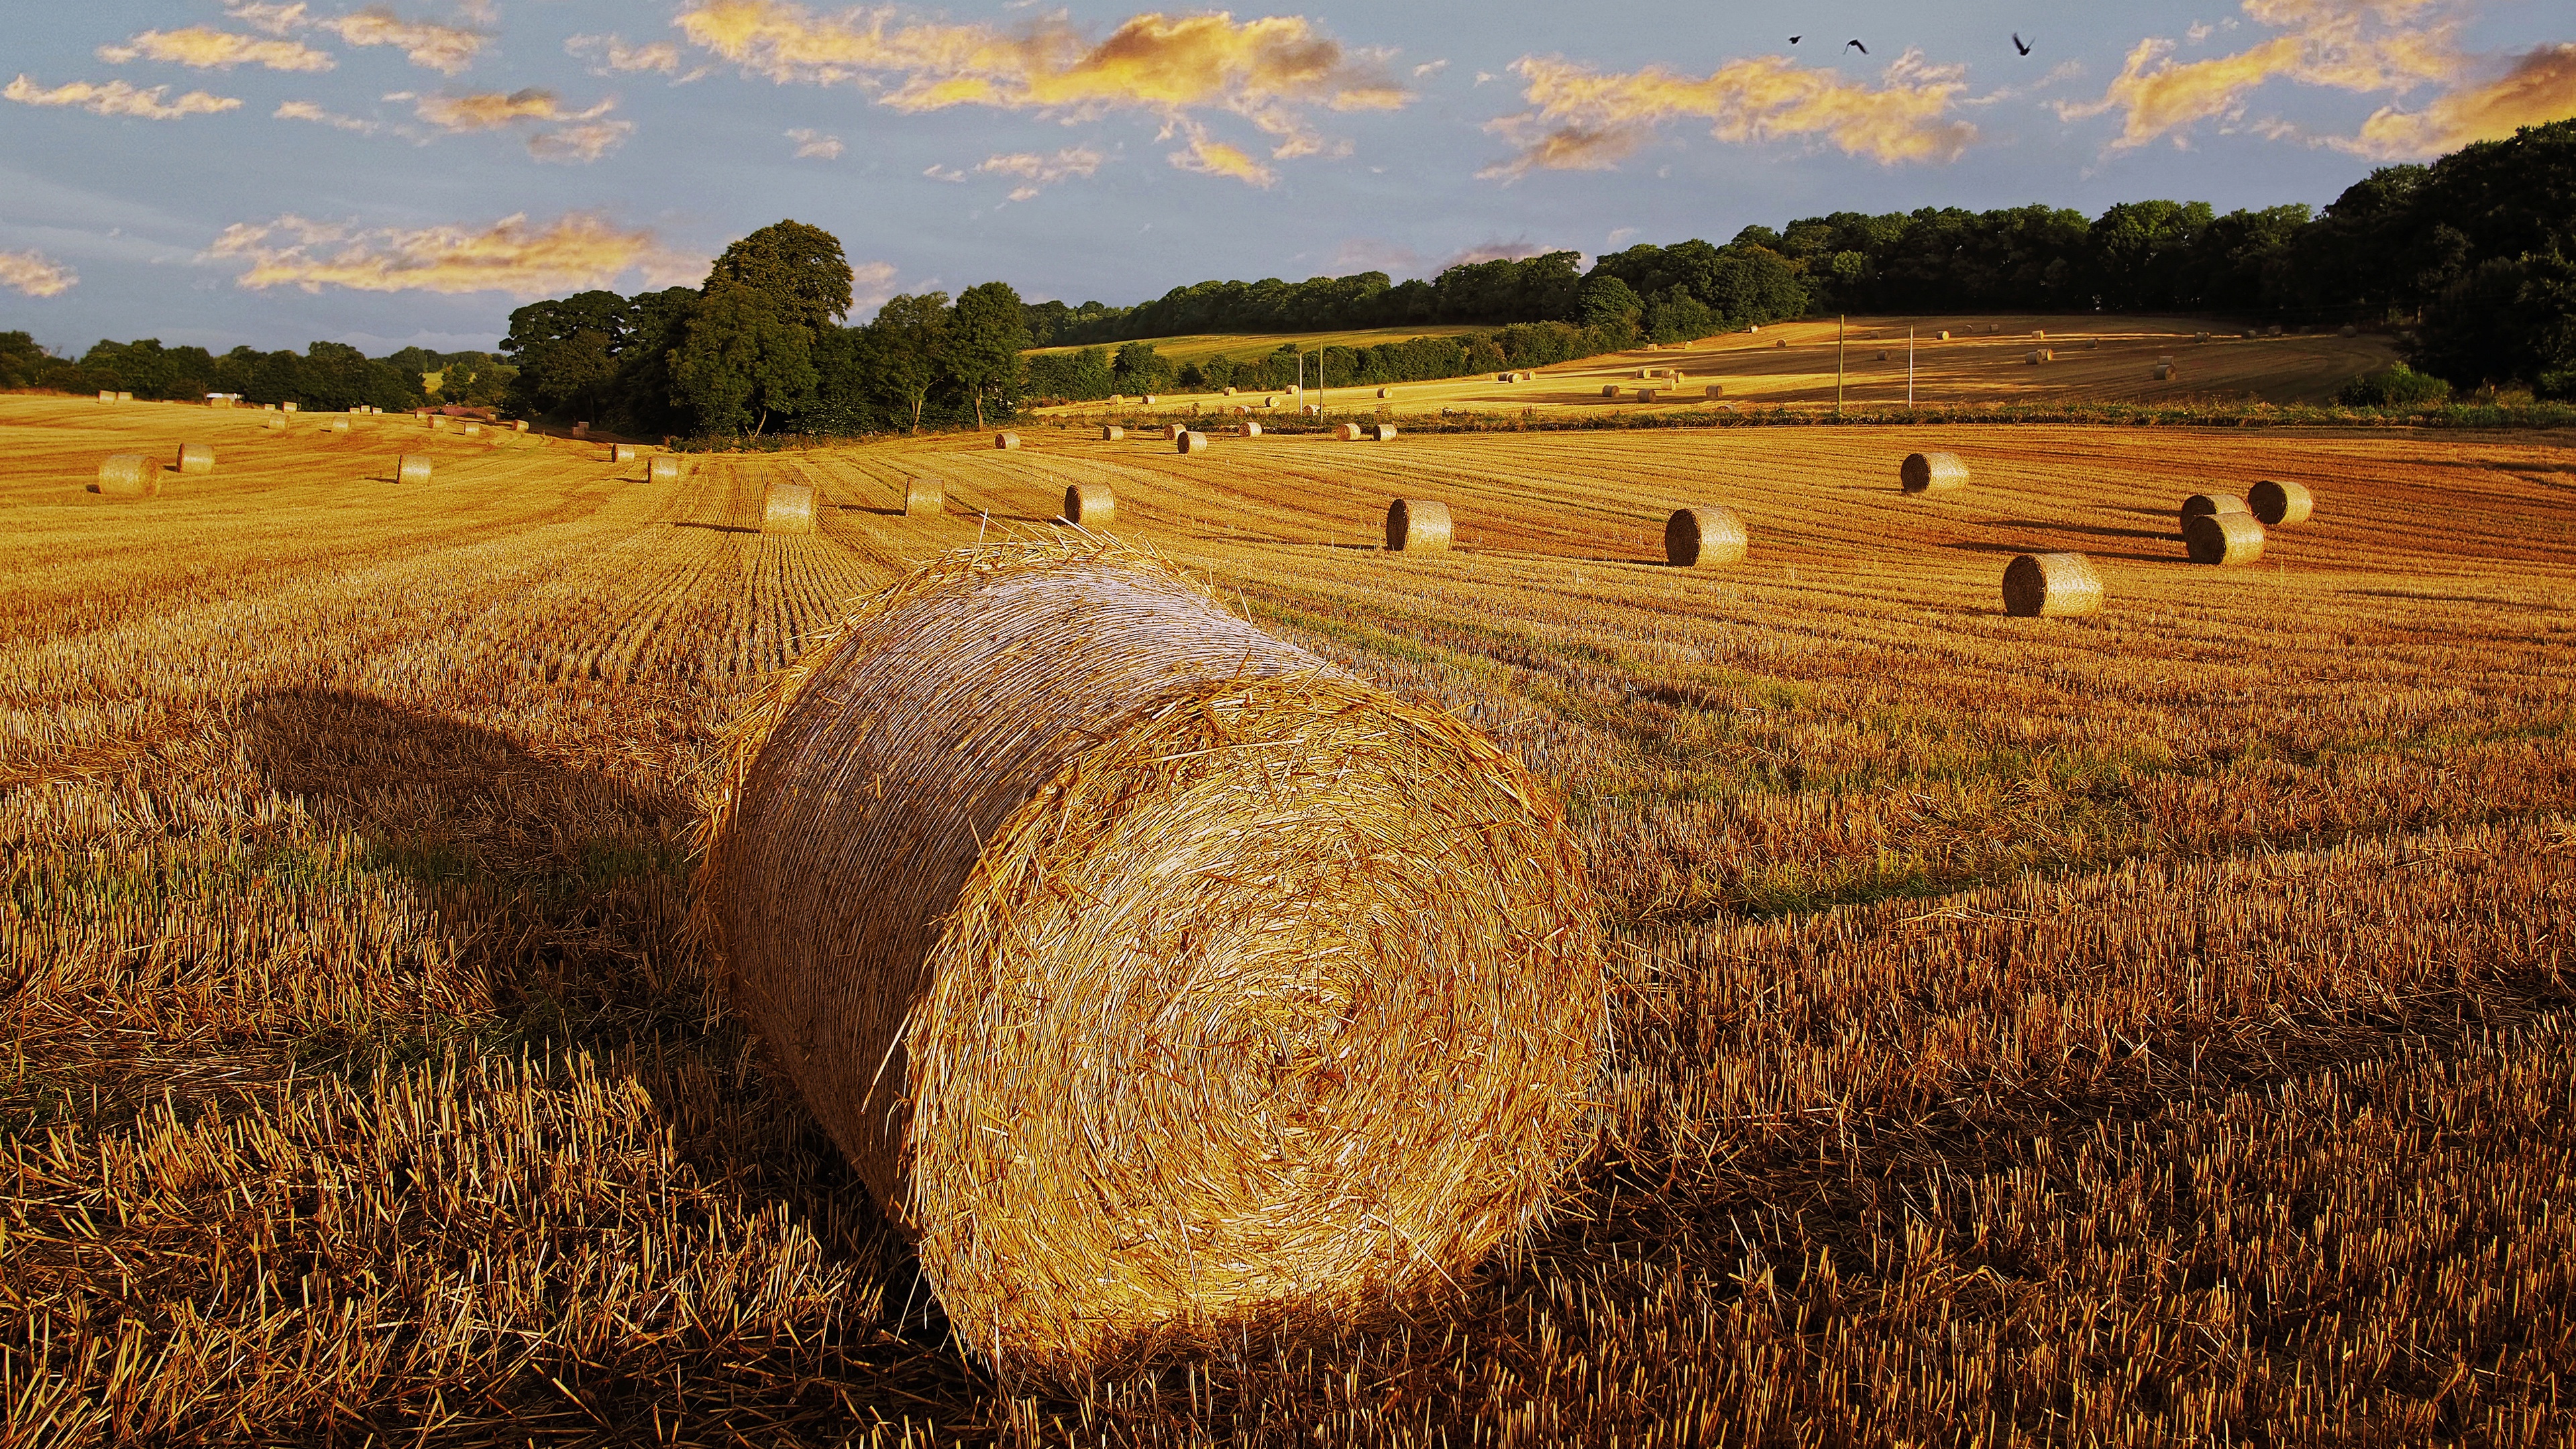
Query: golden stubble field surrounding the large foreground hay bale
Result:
<box><xmin>0</xmin><ymin>389</ymin><xmax>2576</xmax><ymax>1446</ymax></box>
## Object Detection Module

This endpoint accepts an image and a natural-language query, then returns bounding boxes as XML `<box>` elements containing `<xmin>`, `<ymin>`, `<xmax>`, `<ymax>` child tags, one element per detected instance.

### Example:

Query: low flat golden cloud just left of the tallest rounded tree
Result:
<box><xmin>206</xmin><ymin>211</ymin><xmax>706</xmax><ymax>297</ymax></box>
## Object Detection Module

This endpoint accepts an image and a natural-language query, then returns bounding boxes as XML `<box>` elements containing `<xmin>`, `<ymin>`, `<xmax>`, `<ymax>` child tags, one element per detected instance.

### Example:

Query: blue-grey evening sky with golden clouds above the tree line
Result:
<box><xmin>0</xmin><ymin>0</ymin><xmax>2576</xmax><ymax>356</ymax></box>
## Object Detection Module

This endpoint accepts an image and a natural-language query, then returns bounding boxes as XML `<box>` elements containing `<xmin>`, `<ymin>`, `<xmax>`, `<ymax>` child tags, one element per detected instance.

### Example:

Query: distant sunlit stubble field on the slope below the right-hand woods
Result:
<box><xmin>1049</xmin><ymin>317</ymin><xmax>2396</xmax><ymax>418</ymax></box>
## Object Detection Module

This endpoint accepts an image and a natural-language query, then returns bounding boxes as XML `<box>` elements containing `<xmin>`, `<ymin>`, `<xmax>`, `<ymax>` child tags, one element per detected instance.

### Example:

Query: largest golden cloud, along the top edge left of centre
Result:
<box><xmin>675</xmin><ymin>0</ymin><xmax>1411</xmax><ymax>186</ymax></box>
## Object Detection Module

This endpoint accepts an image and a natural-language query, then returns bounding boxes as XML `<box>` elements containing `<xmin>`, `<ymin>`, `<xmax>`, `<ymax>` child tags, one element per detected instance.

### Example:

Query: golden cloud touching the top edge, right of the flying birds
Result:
<box><xmin>2055</xmin><ymin>0</ymin><xmax>2463</xmax><ymax>152</ymax></box>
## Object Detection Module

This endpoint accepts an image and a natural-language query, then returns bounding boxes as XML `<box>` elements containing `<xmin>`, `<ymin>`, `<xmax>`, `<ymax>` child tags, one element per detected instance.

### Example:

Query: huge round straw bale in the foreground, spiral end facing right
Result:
<box><xmin>696</xmin><ymin>547</ymin><xmax>1607</xmax><ymax>1377</ymax></box>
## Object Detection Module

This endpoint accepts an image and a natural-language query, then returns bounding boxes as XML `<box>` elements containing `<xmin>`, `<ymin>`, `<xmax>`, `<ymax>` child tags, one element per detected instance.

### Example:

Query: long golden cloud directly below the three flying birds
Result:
<box><xmin>1481</xmin><ymin>52</ymin><xmax>1976</xmax><ymax>178</ymax></box>
